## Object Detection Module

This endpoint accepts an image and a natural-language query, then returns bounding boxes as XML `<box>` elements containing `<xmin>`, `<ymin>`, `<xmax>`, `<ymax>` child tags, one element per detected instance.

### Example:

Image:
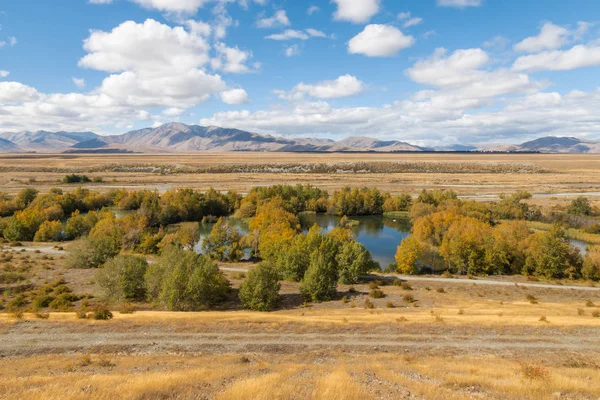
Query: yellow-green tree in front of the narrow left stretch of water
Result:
<box><xmin>202</xmin><ymin>218</ymin><xmax>244</xmax><ymax>261</ymax></box>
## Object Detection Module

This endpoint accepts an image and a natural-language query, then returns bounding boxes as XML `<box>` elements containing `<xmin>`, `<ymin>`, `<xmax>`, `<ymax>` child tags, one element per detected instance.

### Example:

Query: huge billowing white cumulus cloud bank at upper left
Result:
<box><xmin>0</xmin><ymin>20</ymin><xmax>251</xmax><ymax>131</ymax></box>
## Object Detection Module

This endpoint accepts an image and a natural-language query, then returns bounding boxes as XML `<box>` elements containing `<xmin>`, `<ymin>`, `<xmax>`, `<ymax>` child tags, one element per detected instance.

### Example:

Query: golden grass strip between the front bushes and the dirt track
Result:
<box><xmin>0</xmin><ymin>294</ymin><xmax>600</xmax><ymax>327</ymax></box>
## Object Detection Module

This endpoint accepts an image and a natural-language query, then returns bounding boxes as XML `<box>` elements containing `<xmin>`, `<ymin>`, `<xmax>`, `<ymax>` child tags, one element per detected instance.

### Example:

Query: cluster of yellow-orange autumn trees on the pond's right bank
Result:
<box><xmin>396</xmin><ymin>192</ymin><xmax>600</xmax><ymax>280</ymax></box>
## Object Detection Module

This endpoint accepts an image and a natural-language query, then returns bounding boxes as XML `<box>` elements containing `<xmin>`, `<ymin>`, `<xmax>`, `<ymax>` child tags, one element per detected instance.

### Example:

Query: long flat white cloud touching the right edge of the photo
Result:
<box><xmin>513</xmin><ymin>45</ymin><xmax>600</xmax><ymax>72</ymax></box>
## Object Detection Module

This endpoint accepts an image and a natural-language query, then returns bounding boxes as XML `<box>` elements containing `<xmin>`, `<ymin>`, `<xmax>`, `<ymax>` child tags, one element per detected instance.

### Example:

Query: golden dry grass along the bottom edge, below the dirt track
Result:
<box><xmin>0</xmin><ymin>352</ymin><xmax>600</xmax><ymax>400</ymax></box>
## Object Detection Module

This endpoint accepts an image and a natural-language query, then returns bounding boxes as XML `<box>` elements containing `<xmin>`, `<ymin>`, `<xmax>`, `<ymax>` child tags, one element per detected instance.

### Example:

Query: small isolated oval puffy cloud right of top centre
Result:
<box><xmin>348</xmin><ymin>25</ymin><xmax>415</xmax><ymax>57</ymax></box>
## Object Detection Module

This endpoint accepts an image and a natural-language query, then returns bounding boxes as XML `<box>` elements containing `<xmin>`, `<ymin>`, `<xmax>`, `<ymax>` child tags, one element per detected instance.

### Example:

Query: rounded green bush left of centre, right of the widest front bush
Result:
<box><xmin>239</xmin><ymin>262</ymin><xmax>281</xmax><ymax>311</ymax></box>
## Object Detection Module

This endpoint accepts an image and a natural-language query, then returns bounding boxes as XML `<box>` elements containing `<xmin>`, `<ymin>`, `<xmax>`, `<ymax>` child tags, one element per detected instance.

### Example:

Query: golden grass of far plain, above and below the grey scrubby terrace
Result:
<box><xmin>0</xmin><ymin>153</ymin><xmax>600</xmax><ymax>198</ymax></box>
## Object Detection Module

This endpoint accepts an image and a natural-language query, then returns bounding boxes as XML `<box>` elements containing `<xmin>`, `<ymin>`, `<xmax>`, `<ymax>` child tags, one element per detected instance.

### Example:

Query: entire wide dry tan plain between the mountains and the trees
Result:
<box><xmin>0</xmin><ymin>153</ymin><xmax>600</xmax><ymax>200</ymax></box>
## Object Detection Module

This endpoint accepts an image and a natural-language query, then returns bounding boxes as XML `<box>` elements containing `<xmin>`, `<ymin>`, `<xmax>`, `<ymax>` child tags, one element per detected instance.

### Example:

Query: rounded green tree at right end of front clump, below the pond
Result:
<box><xmin>336</xmin><ymin>240</ymin><xmax>375</xmax><ymax>284</ymax></box>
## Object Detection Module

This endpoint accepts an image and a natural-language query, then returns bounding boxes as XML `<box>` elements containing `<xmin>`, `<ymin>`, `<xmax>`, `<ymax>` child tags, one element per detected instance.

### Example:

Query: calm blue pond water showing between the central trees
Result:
<box><xmin>196</xmin><ymin>214</ymin><xmax>410</xmax><ymax>268</ymax></box>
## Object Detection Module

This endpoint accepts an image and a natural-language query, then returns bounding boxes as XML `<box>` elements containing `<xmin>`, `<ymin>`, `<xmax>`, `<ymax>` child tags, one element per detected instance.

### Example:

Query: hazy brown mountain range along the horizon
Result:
<box><xmin>0</xmin><ymin>122</ymin><xmax>600</xmax><ymax>153</ymax></box>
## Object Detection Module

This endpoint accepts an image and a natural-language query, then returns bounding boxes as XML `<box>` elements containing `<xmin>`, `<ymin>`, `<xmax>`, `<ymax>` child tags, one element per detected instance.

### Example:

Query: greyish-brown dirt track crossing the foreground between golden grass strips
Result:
<box><xmin>0</xmin><ymin>321</ymin><xmax>600</xmax><ymax>357</ymax></box>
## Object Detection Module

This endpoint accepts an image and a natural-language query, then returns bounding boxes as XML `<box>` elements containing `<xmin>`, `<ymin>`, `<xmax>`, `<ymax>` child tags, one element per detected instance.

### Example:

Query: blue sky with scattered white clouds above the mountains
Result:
<box><xmin>0</xmin><ymin>0</ymin><xmax>600</xmax><ymax>146</ymax></box>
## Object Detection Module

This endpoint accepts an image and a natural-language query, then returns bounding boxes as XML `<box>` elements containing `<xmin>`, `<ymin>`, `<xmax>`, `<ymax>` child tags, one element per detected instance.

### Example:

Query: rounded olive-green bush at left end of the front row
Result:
<box><xmin>96</xmin><ymin>256</ymin><xmax>148</xmax><ymax>301</ymax></box>
